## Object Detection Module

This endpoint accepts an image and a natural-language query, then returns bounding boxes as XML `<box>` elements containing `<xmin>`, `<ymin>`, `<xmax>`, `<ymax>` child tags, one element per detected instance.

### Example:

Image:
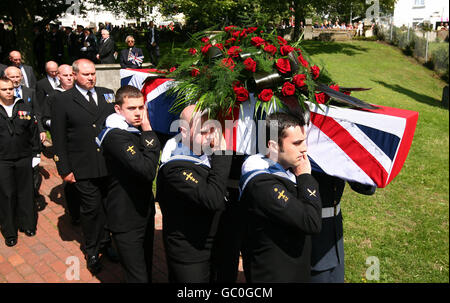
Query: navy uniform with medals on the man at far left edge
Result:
<box><xmin>0</xmin><ymin>99</ymin><xmax>39</xmax><ymax>243</ymax></box>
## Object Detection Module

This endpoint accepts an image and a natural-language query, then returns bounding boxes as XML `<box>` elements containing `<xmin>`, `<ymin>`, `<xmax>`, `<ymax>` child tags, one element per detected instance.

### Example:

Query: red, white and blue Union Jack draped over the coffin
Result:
<box><xmin>122</xmin><ymin>69</ymin><xmax>418</xmax><ymax>188</ymax></box>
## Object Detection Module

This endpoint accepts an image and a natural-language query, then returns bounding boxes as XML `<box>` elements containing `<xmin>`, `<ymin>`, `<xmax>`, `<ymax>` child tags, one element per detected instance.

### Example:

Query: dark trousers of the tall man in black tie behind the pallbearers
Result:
<box><xmin>74</xmin><ymin>177</ymin><xmax>111</xmax><ymax>256</ymax></box>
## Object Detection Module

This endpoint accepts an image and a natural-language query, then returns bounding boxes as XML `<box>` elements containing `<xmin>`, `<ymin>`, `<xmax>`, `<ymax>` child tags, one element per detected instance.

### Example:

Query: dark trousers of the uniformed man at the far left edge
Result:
<box><xmin>0</xmin><ymin>157</ymin><xmax>37</xmax><ymax>239</ymax></box>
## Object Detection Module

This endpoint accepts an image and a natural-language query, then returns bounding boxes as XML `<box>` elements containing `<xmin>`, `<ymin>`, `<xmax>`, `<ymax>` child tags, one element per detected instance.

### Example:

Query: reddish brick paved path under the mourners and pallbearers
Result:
<box><xmin>0</xmin><ymin>155</ymin><xmax>244</xmax><ymax>283</ymax></box>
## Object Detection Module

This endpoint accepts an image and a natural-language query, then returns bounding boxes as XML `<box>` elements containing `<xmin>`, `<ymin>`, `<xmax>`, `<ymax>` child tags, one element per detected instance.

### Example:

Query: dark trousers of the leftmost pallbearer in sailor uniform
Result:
<box><xmin>112</xmin><ymin>216</ymin><xmax>155</xmax><ymax>283</ymax></box>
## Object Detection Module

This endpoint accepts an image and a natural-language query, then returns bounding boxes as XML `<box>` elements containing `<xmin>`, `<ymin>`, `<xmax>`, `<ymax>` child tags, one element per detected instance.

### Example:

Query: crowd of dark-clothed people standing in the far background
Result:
<box><xmin>0</xmin><ymin>19</ymin><xmax>189</xmax><ymax>76</ymax></box>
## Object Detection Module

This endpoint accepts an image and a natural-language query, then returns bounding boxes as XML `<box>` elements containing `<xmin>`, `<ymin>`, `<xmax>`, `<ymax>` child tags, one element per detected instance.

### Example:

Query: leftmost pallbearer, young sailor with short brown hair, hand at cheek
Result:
<box><xmin>97</xmin><ymin>85</ymin><xmax>160</xmax><ymax>283</ymax></box>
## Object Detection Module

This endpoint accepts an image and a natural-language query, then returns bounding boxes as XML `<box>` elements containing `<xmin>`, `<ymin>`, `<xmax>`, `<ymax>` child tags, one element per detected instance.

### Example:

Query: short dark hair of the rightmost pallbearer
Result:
<box><xmin>266</xmin><ymin>113</ymin><xmax>306</xmax><ymax>147</ymax></box>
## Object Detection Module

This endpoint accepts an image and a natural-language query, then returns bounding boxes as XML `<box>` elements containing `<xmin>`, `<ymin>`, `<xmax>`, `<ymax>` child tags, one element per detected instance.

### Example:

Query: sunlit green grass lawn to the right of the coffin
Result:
<box><xmin>303</xmin><ymin>41</ymin><xmax>449</xmax><ymax>283</ymax></box>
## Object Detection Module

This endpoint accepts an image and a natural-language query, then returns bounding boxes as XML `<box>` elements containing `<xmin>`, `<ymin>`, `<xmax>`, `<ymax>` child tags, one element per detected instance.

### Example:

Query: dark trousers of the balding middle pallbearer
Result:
<box><xmin>167</xmin><ymin>259</ymin><xmax>211</xmax><ymax>283</ymax></box>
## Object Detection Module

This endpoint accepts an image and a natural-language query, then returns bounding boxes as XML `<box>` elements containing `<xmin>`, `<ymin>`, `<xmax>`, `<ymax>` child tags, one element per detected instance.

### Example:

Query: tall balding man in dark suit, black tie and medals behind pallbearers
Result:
<box><xmin>51</xmin><ymin>59</ymin><xmax>114</xmax><ymax>273</ymax></box>
